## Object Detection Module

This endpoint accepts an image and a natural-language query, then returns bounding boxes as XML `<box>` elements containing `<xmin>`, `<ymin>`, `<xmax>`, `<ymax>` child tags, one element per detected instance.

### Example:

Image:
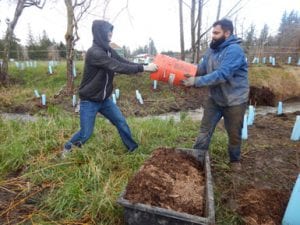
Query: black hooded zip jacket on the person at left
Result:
<box><xmin>79</xmin><ymin>20</ymin><xmax>144</xmax><ymax>102</ymax></box>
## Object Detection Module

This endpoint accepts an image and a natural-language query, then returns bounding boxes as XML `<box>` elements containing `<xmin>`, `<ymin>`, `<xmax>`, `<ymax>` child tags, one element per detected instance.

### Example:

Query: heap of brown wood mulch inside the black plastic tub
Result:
<box><xmin>124</xmin><ymin>148</ymin><xmax>205</xmax><ymax>216</ymax></box>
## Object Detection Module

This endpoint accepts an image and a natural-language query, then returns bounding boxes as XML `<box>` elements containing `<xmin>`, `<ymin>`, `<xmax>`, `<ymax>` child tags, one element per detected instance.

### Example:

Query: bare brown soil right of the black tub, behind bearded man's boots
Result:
<box><xmin>213</xmin><ymin>112</ymin><xmax>300</xmax><ymax>225</ymax></box>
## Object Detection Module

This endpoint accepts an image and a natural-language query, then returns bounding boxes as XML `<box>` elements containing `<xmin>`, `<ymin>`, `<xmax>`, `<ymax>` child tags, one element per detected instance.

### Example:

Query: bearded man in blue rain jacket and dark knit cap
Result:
<box><xmin>183</xmin><ymin>19</ymin><xmax>249</xmax><ymax>171</ymax></box>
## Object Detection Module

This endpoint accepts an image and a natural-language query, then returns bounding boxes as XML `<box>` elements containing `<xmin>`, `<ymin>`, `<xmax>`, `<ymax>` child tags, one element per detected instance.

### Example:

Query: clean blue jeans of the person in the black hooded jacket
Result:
<box><xmin>65</xmin><ymin>99</ymin><xmax>138</xmax><ymax>151</ymax></box>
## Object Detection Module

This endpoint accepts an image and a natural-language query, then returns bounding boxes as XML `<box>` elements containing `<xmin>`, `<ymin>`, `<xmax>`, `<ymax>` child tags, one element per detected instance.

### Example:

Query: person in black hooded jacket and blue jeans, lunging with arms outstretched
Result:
<box><xmin>62</xmin><ymin>20</ymin><xmax>157</xmax><ymax>157</ymax></box>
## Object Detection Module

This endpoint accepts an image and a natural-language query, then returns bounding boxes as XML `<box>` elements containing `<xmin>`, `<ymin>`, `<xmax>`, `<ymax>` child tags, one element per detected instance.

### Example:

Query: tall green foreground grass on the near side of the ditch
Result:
<box><xmin>0</xmin><ymin>116</ymin><xmax>243</xmax><ymax>224</ymax></box>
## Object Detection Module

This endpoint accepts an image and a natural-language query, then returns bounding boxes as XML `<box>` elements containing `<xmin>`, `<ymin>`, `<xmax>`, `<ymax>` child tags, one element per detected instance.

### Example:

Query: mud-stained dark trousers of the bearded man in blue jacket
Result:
<box><xmin>193</xmin><ymin>98</ymin><xmax>247</xmax><ymax>162</ymax></box>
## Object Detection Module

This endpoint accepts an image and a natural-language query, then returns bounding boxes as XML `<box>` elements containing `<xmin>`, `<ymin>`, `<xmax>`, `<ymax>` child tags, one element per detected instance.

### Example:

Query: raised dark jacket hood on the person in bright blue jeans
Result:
<box><xmin>92</xmin><ymin>20</ymin><xmax>114</xmax><ymax>50</ymax></box>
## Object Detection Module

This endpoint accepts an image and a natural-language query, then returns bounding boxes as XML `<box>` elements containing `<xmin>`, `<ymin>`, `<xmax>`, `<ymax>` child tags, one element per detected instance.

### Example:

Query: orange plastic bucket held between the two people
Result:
<box><xmin>150</xmin><ymin>54</ymin><xmax>197</xmax><ymax>85</ymax></box>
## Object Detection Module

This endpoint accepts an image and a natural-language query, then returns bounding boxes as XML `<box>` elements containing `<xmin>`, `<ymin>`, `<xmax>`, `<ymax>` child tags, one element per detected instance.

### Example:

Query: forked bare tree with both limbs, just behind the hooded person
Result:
<box><xmin>64</xmin><ymin>0</ymin><xmax>92</xmax><ymax>95</ymax></box>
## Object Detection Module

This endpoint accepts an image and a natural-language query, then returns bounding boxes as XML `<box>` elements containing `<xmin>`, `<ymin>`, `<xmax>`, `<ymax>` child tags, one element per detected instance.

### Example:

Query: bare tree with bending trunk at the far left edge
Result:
<box><xmin>0</xmin><ymin>0</ymin><xmax>46</xmax><ymax>84</ymax></box>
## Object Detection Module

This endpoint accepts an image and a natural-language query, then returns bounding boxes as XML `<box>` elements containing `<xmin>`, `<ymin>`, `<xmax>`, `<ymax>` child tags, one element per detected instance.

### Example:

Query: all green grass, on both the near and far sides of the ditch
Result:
<box><xmin>0</xmin><ymin>62</ymin><xmax>298</xmax><ymax>225</ymax></box>
